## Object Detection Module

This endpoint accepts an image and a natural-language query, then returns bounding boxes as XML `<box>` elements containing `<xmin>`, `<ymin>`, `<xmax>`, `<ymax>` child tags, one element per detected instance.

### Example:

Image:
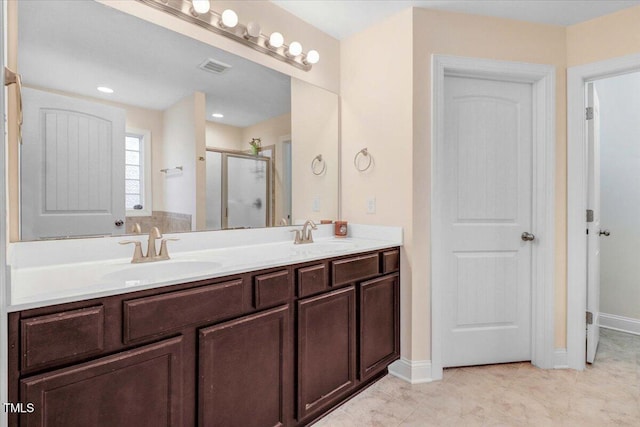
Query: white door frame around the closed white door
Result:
<box><xmin>431</xmin><ymin>55</ymin><xmax>556</xmax><ymax>379</ymax></box>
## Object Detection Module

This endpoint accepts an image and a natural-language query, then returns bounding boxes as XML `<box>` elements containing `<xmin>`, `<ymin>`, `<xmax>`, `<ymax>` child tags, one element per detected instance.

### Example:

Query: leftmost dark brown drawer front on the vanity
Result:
<box><xmin>20</xmin><ymin>305</ymin><xmax>104</xmax><ymax>371</ymax></box>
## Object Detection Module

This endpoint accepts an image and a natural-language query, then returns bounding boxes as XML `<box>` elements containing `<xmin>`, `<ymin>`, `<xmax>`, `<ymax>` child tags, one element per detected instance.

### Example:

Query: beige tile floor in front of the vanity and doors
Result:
<box><xmin>314</xmin><ymin>329</ymin><xmax>640</xmax><ymax>427</ymax></box>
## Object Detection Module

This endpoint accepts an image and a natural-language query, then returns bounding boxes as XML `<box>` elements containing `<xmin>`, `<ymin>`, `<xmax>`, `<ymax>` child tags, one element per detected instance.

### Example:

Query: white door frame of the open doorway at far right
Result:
<box><xmin>567</xmin><ymin>54</ymin><xmax>640</xmax><ymax>370</ymax></box>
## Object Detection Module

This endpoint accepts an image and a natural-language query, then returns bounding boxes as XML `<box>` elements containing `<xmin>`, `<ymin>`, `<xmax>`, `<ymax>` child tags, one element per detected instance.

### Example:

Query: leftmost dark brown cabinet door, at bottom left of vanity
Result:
<box><xmin>20</xmin><ymin>337</ymin><xmax>183</xmax><ymax>427</ymax></box>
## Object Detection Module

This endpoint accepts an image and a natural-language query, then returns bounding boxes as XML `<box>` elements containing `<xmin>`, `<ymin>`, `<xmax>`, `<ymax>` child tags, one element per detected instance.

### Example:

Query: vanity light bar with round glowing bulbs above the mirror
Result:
<box><xmin>136</xmin><ymin>0</ymin><xmax>320</xmax><ymax>71</ymax></box>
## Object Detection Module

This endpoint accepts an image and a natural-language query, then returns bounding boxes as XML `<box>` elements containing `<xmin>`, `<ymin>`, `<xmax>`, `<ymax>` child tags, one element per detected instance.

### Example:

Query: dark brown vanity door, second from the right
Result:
<box><xmin>298</xmin><ymin>286</ymin><xmax>356</xmax><ymax>420</ymax></box>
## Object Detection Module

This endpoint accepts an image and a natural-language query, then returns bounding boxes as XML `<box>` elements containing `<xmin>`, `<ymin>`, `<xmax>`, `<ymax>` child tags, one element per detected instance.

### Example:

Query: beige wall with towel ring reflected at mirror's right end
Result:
<box><xmin>291</xmin><ymin>79</ymin><xmax>340</xmax><ymax>223</ymax></box>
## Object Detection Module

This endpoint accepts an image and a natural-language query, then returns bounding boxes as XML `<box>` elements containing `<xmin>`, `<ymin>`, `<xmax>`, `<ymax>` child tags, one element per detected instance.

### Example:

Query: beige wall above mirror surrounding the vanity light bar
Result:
<box><xmin>98</xmin><ymin>0</ymin><xmax>340</xmax><ymax>93</ymax></box>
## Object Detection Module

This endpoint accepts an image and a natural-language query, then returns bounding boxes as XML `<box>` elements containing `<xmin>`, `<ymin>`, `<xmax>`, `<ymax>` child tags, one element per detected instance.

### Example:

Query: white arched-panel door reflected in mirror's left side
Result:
<box><xmin>20</xmin><ymin>88</ymin><xmax>125</xmax><ymax>240</ymax></box>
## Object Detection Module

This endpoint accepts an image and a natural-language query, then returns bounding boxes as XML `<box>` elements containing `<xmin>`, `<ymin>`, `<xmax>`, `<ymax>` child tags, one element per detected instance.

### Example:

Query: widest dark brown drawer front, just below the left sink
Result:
<box><xmin>123</xmin><ymin>279</ymin><xmax>243</xmax><ymax>343</ymax></box>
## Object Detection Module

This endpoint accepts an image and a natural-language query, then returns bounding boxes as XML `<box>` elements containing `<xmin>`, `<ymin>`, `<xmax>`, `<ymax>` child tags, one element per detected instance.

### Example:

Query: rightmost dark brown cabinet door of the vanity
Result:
<box><xmin>359</xmin><ymin>274</ymin><xmax>400</xmax><ymax>380</ymax></box>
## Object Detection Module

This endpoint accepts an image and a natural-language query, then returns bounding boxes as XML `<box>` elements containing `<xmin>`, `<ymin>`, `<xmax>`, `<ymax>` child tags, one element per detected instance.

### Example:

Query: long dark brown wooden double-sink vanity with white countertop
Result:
<box><xmin>9</xmin><ymin>226</ymin><xmax>401</xmax><ymax>427</ymax></box>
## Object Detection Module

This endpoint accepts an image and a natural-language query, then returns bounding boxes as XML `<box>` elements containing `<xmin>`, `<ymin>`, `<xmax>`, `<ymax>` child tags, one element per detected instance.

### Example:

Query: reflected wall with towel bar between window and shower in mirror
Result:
<box><xmin>162</xmin><ymin>92</ymin><xmax>205</xmax><ymax>230</ymax></box>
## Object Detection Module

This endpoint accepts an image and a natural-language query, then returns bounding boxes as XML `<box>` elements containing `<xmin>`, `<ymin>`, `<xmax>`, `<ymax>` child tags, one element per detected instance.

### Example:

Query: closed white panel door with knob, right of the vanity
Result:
<box><xmin>434</xmin><ymin>76</ymin><xmax>536</xmax><ymax>367</ymax></box>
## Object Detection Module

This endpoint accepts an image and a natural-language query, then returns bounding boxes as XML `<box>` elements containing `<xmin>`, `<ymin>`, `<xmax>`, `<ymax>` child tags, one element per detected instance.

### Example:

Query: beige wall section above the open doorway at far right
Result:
<box><xmin>567</xmin><ymin>6</ymin><xmax>640</xmax><ymax>67</ymax></box>
